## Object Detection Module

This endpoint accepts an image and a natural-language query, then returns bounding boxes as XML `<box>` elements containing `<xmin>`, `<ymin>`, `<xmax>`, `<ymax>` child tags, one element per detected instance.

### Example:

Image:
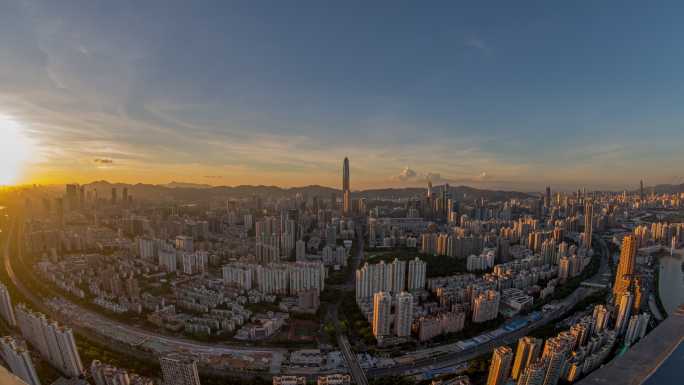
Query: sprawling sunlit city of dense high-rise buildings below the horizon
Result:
<box><xmin>0</xmin><ymin>158</ymin><xmax>684</xmax><ymax>385</ymax></box>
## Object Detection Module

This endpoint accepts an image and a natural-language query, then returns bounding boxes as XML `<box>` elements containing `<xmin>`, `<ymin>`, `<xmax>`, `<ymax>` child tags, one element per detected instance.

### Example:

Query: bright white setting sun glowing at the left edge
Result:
<box><xmin>0</xmin><ymin>115</ymin><xmax>30</xmax><ymax>185</ymax></box>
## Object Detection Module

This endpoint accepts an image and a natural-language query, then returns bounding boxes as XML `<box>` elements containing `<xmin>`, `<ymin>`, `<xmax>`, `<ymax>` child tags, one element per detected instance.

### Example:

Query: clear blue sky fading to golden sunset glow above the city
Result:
<box><xmin>0</xmin><ymin>0</ymin><xmax>684</xmax><ymax>191</ymax></box>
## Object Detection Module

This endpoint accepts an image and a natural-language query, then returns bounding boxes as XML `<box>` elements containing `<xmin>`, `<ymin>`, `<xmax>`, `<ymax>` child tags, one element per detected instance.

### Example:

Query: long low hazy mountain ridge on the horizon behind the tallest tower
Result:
<box><xmin>79</xmin><ymin>181</ymin><xmax>531</xmax><ymax>201</ymax></box>
